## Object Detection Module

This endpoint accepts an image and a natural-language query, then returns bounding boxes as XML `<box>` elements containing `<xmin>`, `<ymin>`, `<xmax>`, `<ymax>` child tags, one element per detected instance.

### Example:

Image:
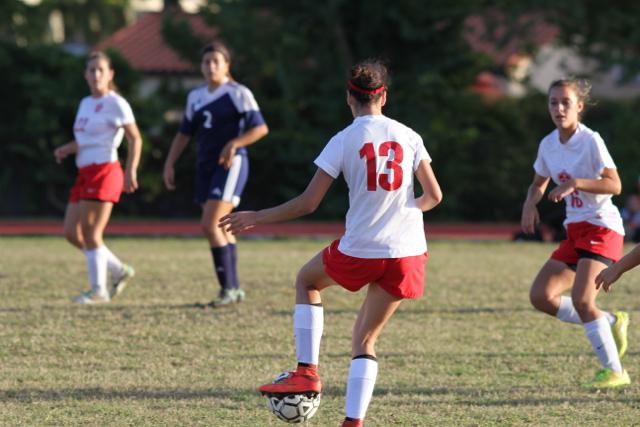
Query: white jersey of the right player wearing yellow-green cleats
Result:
<box><xmin>533</xmin><ymin>123</ymin><xmax>624</xmax><ymax>234</ymax></box>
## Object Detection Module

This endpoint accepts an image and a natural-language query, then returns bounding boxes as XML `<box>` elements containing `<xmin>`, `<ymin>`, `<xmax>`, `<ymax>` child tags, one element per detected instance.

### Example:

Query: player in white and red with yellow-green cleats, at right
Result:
<box><xmin>522</xmin><ymin>79</ymin><xmax>630</xmax><ymax>388</ymax></box>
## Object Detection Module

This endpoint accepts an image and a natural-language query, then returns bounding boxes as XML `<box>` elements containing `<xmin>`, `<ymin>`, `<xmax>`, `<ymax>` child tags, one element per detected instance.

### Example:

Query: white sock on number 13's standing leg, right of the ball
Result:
<box><xmin>345</xmin><ymin>355</ymin><xmax>378</xmax><ymax>420</ymax></box>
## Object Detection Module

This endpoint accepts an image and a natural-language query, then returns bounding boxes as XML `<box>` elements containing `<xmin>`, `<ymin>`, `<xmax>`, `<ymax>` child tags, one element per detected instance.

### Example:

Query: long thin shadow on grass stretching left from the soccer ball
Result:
<box><xmin>0</xmin><ymin>387</ymin><xmax>248</xmax><ymax>403</ymax></box>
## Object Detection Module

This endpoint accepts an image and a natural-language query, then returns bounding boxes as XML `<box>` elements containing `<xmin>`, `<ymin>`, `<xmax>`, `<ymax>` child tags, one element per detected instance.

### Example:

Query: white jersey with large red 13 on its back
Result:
<box><xmin>315</xmin><ymin>115</ymin><xmax>431</xmax><ymax>258</ymax></box>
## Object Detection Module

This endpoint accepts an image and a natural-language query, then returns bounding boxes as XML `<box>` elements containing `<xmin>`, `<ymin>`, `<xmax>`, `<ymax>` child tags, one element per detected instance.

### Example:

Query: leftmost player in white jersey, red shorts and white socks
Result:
<box><xmin>54</xmin><ymin>52</ymin><xmax>142</xmax><ymax>304</ymax></box>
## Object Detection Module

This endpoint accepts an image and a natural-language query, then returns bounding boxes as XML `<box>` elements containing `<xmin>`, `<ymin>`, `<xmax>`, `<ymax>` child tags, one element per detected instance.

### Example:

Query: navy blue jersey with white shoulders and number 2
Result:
<box><xmin>180</xmin><ymin>80</ymin><xmax>264</xmax><ymax>166</ymax></box>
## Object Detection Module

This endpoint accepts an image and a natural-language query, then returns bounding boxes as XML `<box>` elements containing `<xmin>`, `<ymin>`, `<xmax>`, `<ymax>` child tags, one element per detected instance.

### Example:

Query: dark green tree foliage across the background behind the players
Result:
<box><xmin>0</xmin><ymin>0</ymin><xmax>640</xmax><ymax>221</ymax></box>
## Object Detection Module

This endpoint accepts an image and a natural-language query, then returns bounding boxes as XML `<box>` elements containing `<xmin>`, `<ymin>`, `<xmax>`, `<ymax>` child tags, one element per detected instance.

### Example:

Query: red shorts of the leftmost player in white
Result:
<box><xmin>69</xmin><ymin>161</ymin><xmax>124</xmax><ymax>203</ymax></box>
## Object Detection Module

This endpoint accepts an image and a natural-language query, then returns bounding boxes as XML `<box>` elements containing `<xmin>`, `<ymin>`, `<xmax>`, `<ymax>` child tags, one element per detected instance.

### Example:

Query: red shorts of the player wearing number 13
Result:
<box><xmin>322</xmin><ymin>240</ymin><xmax>429</xmax><ymax>298</ymax></box>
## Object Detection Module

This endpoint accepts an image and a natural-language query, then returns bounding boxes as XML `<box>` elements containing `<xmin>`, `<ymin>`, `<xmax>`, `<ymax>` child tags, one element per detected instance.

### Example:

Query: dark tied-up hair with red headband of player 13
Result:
<box><xmin>347</xmin><ymin>59</ymin><xmax>389</xmax><ymax>105</ymax></box>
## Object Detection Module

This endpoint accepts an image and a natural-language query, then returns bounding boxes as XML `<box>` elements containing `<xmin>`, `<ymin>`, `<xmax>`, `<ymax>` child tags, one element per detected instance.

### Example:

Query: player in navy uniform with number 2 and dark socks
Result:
<box><xmin>164</xmin><ymin>41</ymin><xmax>269</xmax><ymax>307</ymax></box>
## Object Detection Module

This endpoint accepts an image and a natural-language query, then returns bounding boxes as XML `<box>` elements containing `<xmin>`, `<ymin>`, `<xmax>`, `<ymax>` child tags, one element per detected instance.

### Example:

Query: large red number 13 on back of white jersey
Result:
<box><xmin>359</xmin><ymin>141</ymin><xmax>403</xmax><ymax>191</ymax></box>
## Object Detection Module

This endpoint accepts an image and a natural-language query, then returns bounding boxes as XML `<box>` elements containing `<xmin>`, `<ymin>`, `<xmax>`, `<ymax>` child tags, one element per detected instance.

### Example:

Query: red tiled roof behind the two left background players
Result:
<box><xmin>94</xmin><ymin>12</ymin><xmax>218</xmax><ymax>74</ymax></box>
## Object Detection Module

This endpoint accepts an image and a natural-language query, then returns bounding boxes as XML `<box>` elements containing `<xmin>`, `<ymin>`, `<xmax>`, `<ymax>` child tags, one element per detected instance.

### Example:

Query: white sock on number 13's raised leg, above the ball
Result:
<box><xmin>293</xmin><ymin>304</ymin><xmax>324</xmax><ymax>365</ymax></box>
